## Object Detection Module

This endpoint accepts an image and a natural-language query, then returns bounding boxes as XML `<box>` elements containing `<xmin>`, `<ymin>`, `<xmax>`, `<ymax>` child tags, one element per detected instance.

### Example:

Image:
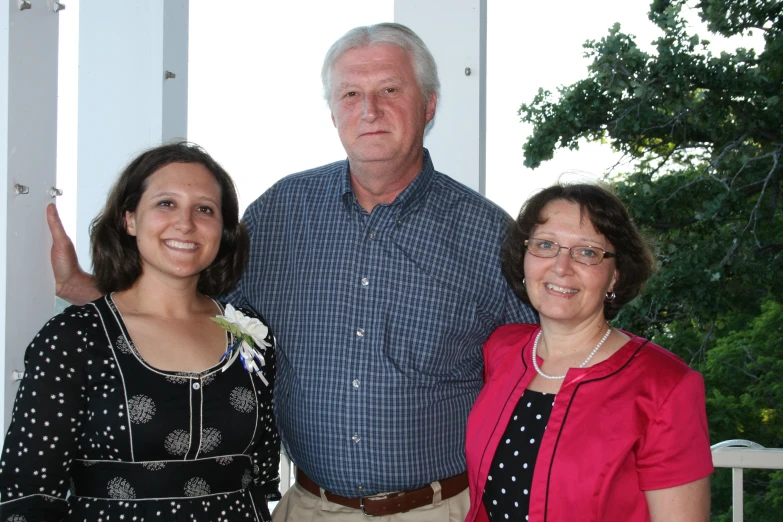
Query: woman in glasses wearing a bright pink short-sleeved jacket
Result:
<box><xmin>467</xmin><ymin>184</ymin><xmax>713</xmax><ymax>522</ymax></box>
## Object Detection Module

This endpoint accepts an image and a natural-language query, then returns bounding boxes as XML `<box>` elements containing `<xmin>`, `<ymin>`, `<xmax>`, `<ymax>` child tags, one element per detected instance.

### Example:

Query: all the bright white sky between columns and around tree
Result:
<box><xmin>58</xmin><ymin>0</ymin><xmax>764</xmax><ymax>238</ymax></box>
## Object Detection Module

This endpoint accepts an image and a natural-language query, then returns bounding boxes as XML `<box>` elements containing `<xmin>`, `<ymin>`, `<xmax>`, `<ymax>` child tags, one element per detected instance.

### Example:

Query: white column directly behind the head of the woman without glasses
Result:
<box><xmin>76</xmin><ymin>0</ymin><xmax>188</xmax><ymax>264</ymax></box>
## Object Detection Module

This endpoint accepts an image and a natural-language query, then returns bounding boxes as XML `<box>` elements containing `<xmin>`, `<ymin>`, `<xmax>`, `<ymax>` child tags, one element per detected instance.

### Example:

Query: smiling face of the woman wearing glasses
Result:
<box><xmin>524</xmin><ymin>200</ymin><xmax>617</xmax><ymax>326</ymax></box>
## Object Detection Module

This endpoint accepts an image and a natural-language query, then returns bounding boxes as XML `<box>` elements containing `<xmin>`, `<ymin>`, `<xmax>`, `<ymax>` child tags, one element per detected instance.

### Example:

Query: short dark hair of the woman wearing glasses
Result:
<box><xmin>501</xmin><ymin>183</ymin><xmax>656</xmax><ymax>320</ymax></box>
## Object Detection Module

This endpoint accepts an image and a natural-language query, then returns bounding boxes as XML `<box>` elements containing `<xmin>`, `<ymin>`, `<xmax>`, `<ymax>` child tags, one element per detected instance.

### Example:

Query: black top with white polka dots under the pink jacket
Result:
<box><xmin>483</xmin><ymin>390</ymin><xmax>555</xmax><ymax>522</ymax></box>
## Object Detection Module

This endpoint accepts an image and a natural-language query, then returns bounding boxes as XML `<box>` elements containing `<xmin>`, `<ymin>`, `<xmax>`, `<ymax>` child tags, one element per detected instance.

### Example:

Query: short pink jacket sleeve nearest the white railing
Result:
<box><xmin>637</xmin><ymin>371</ymin><xmax>714</xmax><ymax>491</ymax></box>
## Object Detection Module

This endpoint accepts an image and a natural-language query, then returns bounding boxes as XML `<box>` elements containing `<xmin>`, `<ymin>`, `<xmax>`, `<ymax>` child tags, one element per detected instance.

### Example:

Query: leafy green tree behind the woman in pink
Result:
<box><xmin>519</xmin><ymin>0</ymin><xmax>783</xmax><ymax>521</ymax></box>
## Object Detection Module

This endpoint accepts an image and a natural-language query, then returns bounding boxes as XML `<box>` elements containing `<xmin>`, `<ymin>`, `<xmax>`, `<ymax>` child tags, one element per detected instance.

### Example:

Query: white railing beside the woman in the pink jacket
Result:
<box><xmin>712</xmin><ymin>439</ymin><xmax>783</xmax><ymax>522</ymax></box>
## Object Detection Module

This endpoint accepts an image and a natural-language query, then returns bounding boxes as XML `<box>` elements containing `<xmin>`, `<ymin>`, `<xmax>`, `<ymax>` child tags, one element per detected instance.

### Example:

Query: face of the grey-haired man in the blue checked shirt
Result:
<box><xmin>329</xmin><ymin>45</ymin><xmax>436</xmax><ymax>168</ymax></box>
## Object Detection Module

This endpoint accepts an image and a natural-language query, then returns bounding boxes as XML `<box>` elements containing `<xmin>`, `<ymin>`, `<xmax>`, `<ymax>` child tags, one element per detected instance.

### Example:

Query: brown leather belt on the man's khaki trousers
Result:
<box><xmin>296</xmin><ymin>468</ymin><xmax>468</xmax><ymax>517</ymax></box>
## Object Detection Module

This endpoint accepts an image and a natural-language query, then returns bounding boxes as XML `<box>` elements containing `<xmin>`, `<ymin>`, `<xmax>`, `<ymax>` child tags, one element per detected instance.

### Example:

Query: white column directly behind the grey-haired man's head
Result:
<box><xmin>394</xmin><ymin>0</ymin><xmax>487</xmax><ymax>194</ymax></box>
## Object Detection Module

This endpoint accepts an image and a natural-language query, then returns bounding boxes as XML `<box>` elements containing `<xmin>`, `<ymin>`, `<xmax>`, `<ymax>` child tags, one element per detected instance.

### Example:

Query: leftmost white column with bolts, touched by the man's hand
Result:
<box><xmin>0</xmin><ymin>0</ymin><xmax>59</xmax><ymax>426</ymax></box>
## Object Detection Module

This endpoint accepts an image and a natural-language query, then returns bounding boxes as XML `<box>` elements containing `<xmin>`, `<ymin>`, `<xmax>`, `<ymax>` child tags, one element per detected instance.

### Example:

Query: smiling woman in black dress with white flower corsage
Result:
<box><xmin>0</xmin><ymin>143</ymin><xmax>279</xmax><ymax>522</ymax></box>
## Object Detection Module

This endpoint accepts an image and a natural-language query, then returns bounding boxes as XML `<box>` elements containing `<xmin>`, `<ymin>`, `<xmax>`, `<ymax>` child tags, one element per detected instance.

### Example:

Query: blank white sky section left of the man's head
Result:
<box><xmin>188</xmin><ymin>0</ymin><xmax>394</xmax><ymax>213</ymax></box>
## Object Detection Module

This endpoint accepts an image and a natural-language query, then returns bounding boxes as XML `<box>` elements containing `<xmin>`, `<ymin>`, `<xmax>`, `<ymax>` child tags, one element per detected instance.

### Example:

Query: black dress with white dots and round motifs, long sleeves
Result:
<box><xmin>0</xmin><ymin>296</ymin><xmax>280</xmax><ymax>522</ymax></box>
